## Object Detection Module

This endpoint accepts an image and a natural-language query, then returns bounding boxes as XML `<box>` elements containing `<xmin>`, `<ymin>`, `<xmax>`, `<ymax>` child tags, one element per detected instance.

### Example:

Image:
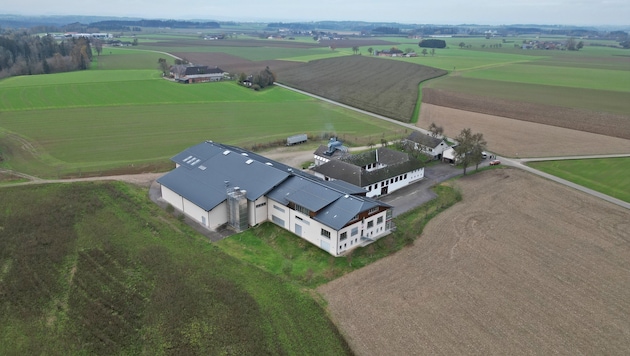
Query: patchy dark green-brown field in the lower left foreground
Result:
<box><xmin>0</xmin><ymin>182</ymin><xmax>352</xmax><ymax>355</ymax></box>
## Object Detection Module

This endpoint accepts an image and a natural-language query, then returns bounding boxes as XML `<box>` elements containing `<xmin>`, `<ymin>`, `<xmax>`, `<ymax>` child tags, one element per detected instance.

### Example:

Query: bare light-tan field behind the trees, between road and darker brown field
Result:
<box><xmin>417</xmin><ymin>103</ymin><xmax>630</xmax><ymax>157</ymax></box>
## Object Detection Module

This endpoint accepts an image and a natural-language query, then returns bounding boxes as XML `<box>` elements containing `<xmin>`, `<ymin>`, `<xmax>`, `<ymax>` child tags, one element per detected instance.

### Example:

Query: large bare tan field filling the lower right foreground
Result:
<box><xmin>318</xmin><ymin>169</ymin><xmax>630</xmax><ymax>355</ymax></box>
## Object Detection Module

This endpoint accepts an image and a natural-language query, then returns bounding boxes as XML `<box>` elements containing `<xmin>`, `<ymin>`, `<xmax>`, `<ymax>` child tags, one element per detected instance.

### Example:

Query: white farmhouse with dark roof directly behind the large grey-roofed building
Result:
<box><xmin>312</xmin><ymin>147</ymin><xmax>424</xmax><ymax>197</ymax></box>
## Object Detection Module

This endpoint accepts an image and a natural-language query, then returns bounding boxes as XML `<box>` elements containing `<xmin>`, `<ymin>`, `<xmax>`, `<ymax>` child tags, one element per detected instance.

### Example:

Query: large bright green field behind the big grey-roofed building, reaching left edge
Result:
<box><xmin>0</xmin><ymin>49</ymin><xmax>402</xmax><ymax>178</ymax></box>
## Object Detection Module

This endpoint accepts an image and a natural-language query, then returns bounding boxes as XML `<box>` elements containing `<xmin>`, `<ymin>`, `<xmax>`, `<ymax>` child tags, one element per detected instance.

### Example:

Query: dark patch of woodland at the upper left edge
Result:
<box><xmin>0</xmin><ymin>32</ymin><xmax>92</xmax><ymax>79</ymax></box>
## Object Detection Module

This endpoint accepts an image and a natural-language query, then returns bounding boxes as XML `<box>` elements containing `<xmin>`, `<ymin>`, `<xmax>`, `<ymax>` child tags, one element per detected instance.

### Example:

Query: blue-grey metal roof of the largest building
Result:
<box><xmin>158</xmin><ymin>141</ymin><xmax>390</xmax><ymax>230</ymax></box>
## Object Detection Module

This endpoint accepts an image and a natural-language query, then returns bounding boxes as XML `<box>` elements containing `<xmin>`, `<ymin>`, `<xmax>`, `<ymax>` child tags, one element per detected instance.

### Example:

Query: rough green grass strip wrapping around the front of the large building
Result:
<box><xmin>216</xmin><ymin>184</ymin><xmax>462</xmax><ymax>288</ymax></box>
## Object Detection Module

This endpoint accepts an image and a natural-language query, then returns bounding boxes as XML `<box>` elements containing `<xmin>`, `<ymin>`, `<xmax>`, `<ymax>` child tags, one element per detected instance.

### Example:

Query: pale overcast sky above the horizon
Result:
<box><xmin>0</xmin><ymin>0</ymin><xmax>630</xmax><ymax>26</ymax></box>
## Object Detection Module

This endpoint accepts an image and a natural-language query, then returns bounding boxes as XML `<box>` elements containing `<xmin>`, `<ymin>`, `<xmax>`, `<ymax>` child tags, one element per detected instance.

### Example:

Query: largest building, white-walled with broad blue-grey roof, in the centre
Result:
<box><xmin>157</xmin><ymin>141</ymin><xmax>393</xmax><ymax>256</ymax></box>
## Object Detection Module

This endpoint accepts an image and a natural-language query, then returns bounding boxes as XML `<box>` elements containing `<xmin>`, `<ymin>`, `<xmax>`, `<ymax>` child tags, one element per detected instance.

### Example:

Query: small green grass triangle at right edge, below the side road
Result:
<box><xmin>528</xmin><ymin>157</ymin><xmax>630</xmax><ymax>202</ymax></box>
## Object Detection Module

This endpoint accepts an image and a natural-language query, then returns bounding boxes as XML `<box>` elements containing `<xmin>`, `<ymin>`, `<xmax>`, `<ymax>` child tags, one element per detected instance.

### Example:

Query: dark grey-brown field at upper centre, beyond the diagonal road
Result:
<box><xmin>277</xmin><ymin>56</ymin><xmax>446</xmax><ymax>122</ymax></box>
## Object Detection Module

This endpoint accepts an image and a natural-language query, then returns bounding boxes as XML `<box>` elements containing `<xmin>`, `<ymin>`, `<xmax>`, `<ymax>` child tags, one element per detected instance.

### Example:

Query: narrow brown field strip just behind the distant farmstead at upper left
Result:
<box><xmin>173</xmin><ymin>52</ymin><xmax>304</xmax><ymax>74</ymax></box>
